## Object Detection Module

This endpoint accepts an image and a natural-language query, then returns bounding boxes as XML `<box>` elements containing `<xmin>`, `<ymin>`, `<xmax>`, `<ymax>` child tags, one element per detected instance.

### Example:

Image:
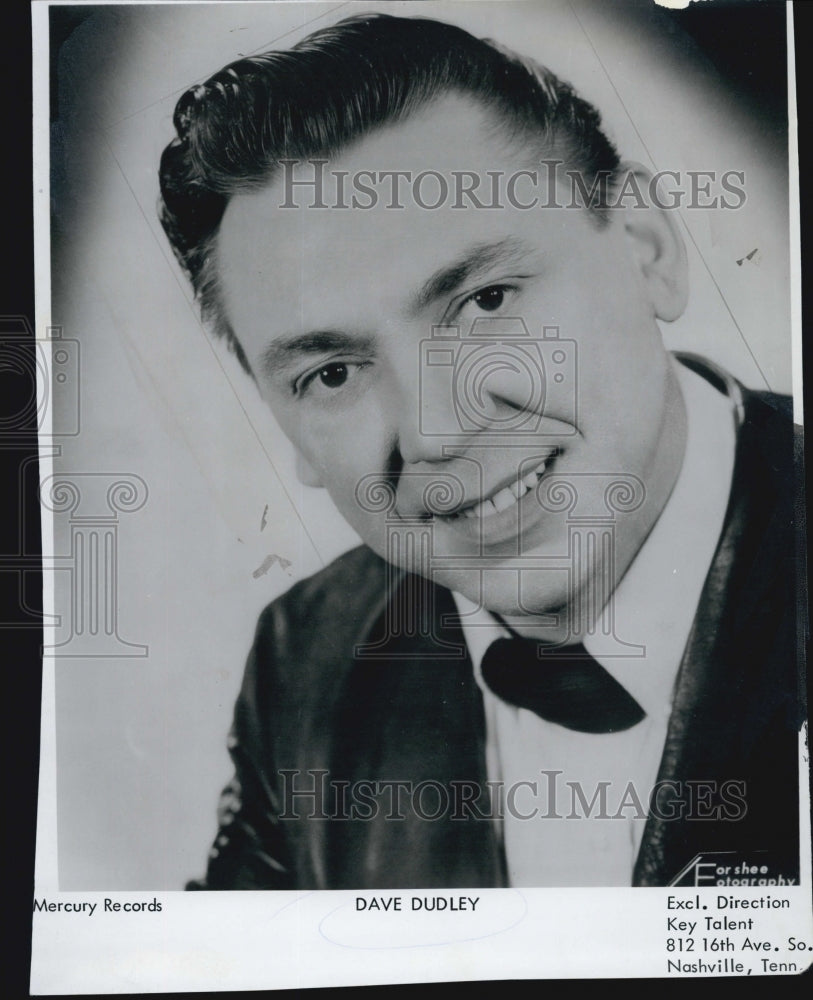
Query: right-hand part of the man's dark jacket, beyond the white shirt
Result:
<box><xmin>633</xmin><ymin>386</ymin><xmax>798</xmax><ymax>885</ymax></box>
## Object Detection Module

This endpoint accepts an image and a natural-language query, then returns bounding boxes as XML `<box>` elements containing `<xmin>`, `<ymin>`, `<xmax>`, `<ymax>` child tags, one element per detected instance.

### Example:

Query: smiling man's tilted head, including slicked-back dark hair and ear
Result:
<box><xmin>161</xmin><ymin>16</ymin><xmax>685</xmax><ymax>640</ymax></box>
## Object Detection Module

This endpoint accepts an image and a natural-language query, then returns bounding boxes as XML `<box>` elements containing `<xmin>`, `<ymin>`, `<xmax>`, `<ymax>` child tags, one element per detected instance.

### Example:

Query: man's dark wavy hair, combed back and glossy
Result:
<box><xmin>159</xmin><ymin>14</ymin><xmax>619</xmax><ymax>373</ymax></box>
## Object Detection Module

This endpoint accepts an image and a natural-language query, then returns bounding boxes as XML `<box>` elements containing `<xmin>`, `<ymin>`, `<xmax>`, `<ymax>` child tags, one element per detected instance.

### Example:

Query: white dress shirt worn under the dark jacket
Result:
<box><xmin>454</xmin><ymin>362</ymin><xmax>736</xmax><ymax>886</ymax></box>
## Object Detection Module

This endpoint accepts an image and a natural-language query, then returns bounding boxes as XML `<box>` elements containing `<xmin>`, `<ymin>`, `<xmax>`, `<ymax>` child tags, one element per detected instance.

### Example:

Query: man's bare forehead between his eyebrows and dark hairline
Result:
<box><xmin>217</xmin><ymin>95</ymin><xmax>588</xmax><ymax>348</ymax></box>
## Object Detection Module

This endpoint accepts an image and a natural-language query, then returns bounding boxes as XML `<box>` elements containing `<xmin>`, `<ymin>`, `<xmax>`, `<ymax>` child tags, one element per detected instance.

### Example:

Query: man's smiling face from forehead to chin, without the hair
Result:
<box><xmin>217</xmin><ymin>96</ymin><xmax>683</xmax><ymax>637</ymax></box>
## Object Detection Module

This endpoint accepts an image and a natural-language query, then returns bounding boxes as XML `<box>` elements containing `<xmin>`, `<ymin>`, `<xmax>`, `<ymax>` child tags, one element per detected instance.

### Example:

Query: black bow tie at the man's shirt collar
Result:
<box><xmin>480</xmin><ymin>637</ymin><xmax>645</xmax><ymax>733</ymax></box>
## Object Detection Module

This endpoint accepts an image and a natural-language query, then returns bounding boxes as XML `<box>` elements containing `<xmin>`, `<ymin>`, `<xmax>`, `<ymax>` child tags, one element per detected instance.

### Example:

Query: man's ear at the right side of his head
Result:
<box><xmin>612</xmin><ymin>163</ymin><xmax>689</xmax><ymax>322</ymax></box>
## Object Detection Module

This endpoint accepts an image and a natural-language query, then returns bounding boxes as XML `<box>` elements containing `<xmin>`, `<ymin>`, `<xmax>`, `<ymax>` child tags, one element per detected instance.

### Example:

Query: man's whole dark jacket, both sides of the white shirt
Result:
<box><xmin>189</xmin><ymin>378</ymin><xmax>805</xmax><ymax>889</ymax></box>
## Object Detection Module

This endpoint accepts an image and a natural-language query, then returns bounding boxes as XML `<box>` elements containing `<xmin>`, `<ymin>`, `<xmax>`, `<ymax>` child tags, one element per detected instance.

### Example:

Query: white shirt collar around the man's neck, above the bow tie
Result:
<box><xmin>454</xmin><ymin>362</ymin><xmax>736</xmax><ymax>716</ymax></box>
